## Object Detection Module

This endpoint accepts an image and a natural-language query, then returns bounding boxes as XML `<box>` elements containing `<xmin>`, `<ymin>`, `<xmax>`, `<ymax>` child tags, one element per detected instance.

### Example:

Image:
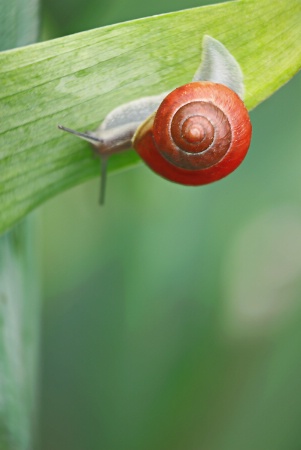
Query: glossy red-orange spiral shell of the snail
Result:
<box><xmin>133</xmin><ymin>81</ymin><xmax>252</xmax><ymax>185</ymax></box>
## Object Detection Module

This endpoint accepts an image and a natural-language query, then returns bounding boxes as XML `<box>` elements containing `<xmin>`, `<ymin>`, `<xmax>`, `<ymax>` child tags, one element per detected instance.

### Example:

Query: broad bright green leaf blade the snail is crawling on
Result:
<box><xmin>0</xmin><ymin>0</ymin><xmax>301</xmax><ymax>232</ymax></box>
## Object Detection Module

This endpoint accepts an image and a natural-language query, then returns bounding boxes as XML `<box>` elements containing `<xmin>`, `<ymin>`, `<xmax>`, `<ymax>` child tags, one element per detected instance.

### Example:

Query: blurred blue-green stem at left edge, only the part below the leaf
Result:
<box><xmin>0</xmin><ymin>218</ymin><xmax>40</xmax><ymax>450</ymax></box>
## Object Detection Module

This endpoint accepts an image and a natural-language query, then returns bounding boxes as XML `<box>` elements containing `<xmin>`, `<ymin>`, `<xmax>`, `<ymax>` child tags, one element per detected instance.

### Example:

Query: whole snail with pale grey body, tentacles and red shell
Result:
<box><xmin>58</xmin><ymin>36</ymin><xmax>252</xmax><ymax>204</ymax></box>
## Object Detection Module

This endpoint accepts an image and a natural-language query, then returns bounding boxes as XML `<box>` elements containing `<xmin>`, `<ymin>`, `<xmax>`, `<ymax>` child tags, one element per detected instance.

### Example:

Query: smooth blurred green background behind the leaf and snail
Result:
<box><xmin>37</xmin><ymin>0</ymin><xmax>301</xmax><ymax>450</ymax></box>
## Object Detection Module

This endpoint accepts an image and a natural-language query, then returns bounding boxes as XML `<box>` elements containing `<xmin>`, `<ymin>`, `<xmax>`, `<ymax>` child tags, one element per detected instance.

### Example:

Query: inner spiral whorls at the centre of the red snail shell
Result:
<box><xmin>153</xmin><ymin>83</ymin><xmax>232</xmax><ymax>170</ymax></box>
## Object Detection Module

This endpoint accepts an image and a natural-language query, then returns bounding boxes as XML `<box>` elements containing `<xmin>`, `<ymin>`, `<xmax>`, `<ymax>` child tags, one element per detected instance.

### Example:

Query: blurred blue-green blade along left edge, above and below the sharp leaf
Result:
<box><xmin>0</xmin><ymin>0</ymin><xmax>40</xmax><ymax>450</ymax></box>
